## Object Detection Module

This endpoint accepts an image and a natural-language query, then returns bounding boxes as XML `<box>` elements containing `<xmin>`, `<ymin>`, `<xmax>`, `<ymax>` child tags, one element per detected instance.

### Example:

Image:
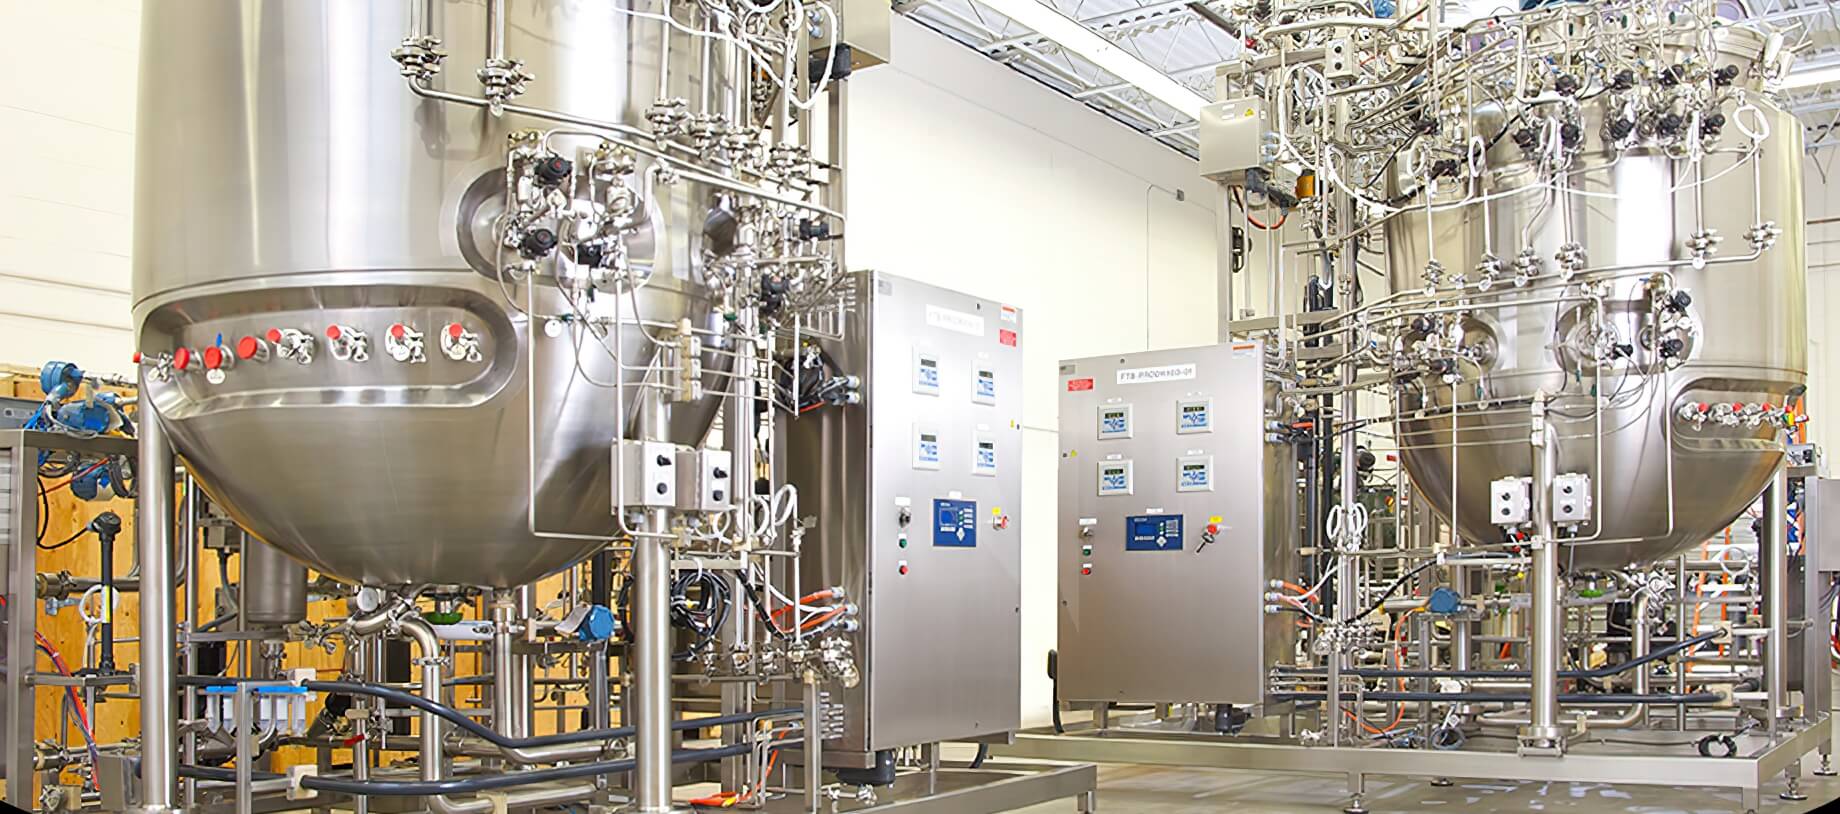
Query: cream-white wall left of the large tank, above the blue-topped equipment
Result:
<box><xmin>0</xmin><ymin>0</ymin><xmax>140</xmax><ymax>372</ymax></box>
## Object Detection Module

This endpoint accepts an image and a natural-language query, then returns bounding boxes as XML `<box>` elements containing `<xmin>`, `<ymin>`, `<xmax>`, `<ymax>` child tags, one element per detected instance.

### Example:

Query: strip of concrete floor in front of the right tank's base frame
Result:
<box><xmin>1023</xmin><ymin>764</ymin><xmax>1840</xmax><ymax>814</ymax></box>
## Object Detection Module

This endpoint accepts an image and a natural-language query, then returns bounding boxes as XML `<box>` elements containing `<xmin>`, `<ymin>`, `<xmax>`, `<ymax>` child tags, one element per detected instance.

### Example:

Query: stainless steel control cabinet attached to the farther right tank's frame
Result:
<box><xmin>1056</xmin><ymin>343</ymin><xmax>1295</xmax><ymax>704</ymax></box>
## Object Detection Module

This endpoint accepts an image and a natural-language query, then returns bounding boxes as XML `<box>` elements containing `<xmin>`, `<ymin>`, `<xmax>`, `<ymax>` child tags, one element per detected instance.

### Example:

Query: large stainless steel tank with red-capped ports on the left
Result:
<box><xmin>134</xmin><ymin>0</ymin><xmax>743</xmax><ymax>586</ymax></box>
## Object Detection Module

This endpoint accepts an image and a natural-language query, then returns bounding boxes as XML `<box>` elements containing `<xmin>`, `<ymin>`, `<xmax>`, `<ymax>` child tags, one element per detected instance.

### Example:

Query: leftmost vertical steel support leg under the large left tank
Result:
<box><xmin>134</xmin><ymin>403</ymin><xmax>178</xmax><ymax>812</ymax></box>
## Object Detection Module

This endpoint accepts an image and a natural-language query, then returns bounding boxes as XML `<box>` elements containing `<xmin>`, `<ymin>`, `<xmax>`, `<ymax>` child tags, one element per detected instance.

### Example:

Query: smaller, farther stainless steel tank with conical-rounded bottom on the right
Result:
<box><xmin>1386</xmin><ymin>29</ymin><xmax>1807</xmax><ymax>569</ymax></box>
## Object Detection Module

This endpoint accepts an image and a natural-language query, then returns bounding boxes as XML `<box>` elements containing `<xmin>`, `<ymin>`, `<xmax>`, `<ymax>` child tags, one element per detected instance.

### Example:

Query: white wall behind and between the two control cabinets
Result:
<box><xmin>845</xmin><ymin>18</ymin><xmax>1214</xmax><ymax>724</ymax></box>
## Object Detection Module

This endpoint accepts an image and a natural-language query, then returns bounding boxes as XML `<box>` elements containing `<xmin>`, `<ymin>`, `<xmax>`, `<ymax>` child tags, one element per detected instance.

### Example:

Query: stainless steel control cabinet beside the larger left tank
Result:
<box><xmin>780</xmin><ymin>273</ymin><xmax>1025</xmax><ymax>764</ymax></box>
